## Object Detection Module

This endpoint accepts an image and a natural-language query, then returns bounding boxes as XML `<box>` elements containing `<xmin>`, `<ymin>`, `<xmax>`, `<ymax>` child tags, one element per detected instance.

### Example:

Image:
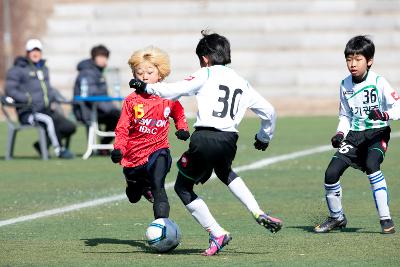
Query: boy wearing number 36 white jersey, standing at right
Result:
<box><xmin>314</xmin><ymin>36</ymin><xmax>400</xmax><ymax>234</ymax></box>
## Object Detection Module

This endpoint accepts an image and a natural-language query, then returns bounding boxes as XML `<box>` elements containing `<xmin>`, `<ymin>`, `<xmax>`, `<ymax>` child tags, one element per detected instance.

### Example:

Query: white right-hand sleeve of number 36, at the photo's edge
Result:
<box><xmin>377</xmin><ymin>77</ymin><xmax>400</xmax><ymax>120</ymax></box>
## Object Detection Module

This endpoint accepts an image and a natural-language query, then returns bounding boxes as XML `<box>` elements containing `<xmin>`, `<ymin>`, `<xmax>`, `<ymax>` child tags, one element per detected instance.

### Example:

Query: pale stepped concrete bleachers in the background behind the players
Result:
<box><xmin>3</xmin><ymin>0</ymin><xmax>400</xmax><ymax>114</ymax></box>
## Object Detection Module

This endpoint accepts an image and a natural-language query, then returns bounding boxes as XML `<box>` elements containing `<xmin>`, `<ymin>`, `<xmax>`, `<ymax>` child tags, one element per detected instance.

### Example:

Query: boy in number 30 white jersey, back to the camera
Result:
<box><xmin>129</xmin><ymin>31</ymin><xmax>282</xmax><ymax>256</ymax></box>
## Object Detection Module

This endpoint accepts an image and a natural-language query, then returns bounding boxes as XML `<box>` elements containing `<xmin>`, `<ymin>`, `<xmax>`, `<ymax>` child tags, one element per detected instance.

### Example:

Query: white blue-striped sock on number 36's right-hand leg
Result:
<box><xmin>368</xmin><ymin>171</ymin><xmax>390</xmax><ymax>220</ymax></box>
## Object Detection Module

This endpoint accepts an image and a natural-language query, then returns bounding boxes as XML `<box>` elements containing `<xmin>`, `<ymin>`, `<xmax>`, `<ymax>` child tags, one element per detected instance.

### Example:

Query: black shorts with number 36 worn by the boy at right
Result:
<box><xmin>334</xmin><ymin>126</ymin><xmax>391</xmax><ymax>171</ymax></box>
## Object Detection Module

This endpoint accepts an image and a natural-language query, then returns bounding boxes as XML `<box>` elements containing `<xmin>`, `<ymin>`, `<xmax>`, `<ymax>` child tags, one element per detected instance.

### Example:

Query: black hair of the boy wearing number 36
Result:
<box><xmin>344</xmin><ymin>35</ymin><xmax>375</xmax><ymax>61</ymax></box>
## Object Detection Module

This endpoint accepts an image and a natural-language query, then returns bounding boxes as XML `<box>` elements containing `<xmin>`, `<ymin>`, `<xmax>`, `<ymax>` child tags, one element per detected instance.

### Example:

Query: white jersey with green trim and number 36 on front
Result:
<box><xmin>337</xmin><ymin>71</ymin><xmax>400</xmax><ymax>134</ymax></box>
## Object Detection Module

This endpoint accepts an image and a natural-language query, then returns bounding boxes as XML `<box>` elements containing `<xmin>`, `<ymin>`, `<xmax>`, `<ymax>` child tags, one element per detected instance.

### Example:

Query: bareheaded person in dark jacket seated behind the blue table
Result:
<box><xmin>73</xmin><ymin>45</ymin><xmax>120</xmax><ymax>153</ymax></box>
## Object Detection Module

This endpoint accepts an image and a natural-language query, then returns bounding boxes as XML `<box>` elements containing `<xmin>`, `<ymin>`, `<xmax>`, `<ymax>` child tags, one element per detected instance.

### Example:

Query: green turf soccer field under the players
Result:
<box><xmin>0</xmin><ymin>117</ymin><xmax>400</xmax><ymax>266</ymax></box>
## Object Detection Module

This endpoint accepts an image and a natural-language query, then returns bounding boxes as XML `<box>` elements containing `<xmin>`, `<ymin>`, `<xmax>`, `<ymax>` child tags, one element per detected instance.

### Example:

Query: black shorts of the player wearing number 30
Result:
<box><xmin>177</xmin><ymin>127</ymin><xmax>238</xmax><ymax>184</ymax></box>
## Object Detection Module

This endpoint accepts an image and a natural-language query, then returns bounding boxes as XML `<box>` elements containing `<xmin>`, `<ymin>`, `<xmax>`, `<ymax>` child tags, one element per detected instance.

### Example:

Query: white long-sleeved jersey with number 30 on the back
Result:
<box><xmin>146</xmin><ymin>65</ymin><xmax>276</xmax><ymax>142</ymax></box>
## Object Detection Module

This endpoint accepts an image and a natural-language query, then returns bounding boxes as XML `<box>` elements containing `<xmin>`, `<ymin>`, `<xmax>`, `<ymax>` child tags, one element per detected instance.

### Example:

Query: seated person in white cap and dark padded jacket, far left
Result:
<box><xmin>5</xmin><ymin>39</ymin><xmax>76</xmax><ymax>159</ymax></box>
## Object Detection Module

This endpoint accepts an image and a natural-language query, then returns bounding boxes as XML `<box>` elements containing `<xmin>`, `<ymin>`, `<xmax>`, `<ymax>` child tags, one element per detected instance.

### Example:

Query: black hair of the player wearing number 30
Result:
<box><xmin>196</xmin><ymin>30</ymin><xmax>231</xmax><ymax>65</ymax></box>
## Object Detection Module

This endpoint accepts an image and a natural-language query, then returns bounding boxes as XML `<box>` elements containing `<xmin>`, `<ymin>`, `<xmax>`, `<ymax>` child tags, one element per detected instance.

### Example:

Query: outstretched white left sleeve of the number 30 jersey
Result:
<box><xmin>146</xmin><ymin>68</ymin><xmax>209</xmax><ymax>100</ymax></box>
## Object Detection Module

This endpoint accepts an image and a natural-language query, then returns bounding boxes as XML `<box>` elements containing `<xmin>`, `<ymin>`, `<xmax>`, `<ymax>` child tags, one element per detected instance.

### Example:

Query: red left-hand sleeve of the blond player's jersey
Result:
<box><xmin>114</xmin><ymin>100</ymin><xmax>132</xmax><ymax>154</ymax></box>
